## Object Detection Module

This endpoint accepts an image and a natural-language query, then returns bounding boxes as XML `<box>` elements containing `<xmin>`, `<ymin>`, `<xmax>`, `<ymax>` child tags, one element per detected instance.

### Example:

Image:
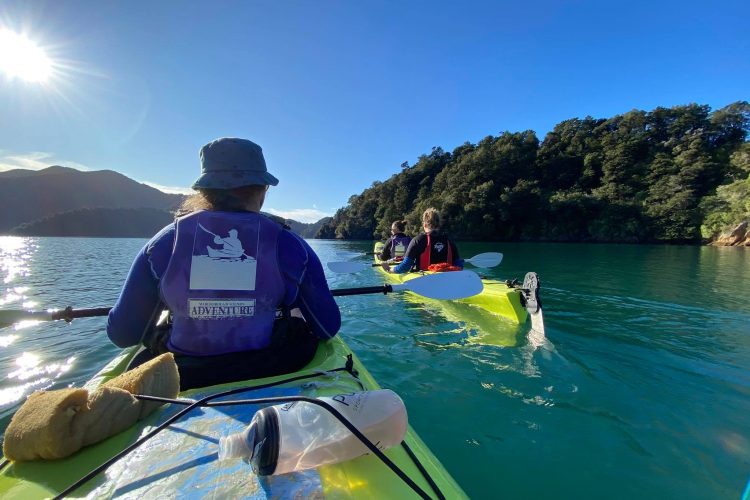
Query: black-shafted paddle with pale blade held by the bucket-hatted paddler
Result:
<box><xmin>0</xmin><ymin>271</ymin><xmax>484</xmax><ymax>328</ymax></box>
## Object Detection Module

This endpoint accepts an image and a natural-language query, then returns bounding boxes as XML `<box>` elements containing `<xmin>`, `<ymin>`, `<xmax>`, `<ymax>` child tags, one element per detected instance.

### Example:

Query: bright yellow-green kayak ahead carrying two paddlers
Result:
<box><xmin>374</xmin><ymin>242</ymin><xmax>529</xmax><ymax>325</ymax></box>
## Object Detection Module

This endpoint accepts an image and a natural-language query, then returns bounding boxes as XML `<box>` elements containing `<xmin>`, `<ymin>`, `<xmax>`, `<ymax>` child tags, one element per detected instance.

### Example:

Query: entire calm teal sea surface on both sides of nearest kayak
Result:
<box><xmin>0</xmin><ymin>237</ymin><xmax>750</xmax><ymax>499</ymax></box>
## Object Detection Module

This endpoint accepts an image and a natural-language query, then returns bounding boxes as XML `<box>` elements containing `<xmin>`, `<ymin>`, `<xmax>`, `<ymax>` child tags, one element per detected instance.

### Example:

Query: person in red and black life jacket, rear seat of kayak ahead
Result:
<box><xmin>383</xmin><ymin>208</ymin><xmax>464</xmax><ymax>274</ymax></box>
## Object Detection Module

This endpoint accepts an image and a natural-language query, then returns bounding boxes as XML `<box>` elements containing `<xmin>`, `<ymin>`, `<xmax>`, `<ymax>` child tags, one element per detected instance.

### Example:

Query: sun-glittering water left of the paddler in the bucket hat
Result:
<box><xmin>0</xmin><ymin>237</ymin><xmax>145</xmax><ymax>422</ymax></box>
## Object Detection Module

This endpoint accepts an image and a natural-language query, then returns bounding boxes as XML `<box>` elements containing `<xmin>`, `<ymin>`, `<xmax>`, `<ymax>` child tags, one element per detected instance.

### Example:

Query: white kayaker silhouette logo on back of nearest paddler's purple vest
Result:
<box><xmin>190</xmin><ymin>220</ymin><xmax>258</xmax><ymax>290</ymax></box>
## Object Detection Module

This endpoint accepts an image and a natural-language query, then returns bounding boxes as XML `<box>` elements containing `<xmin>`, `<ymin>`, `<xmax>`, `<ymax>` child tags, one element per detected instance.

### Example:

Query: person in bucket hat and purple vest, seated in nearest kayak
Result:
<box><xmin>107</xmin><ymin>138</ymin><xmax>341</xmax><ymax>390</ymax></box>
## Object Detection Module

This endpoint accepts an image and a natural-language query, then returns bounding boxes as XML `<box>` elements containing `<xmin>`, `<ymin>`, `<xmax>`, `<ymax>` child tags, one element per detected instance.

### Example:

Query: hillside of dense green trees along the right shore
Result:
<box><xmin>318</xmin><ymin>102</ymin><xmax>750</xmax><ymax>242</ymax></box>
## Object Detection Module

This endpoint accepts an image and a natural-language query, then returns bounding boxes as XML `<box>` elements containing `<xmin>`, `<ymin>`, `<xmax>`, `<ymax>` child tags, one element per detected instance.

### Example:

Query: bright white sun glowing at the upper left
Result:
<box><xmin>0</xmin><ymin>28</ymin><xmax>54</xmax><ymax>83</ymax></box>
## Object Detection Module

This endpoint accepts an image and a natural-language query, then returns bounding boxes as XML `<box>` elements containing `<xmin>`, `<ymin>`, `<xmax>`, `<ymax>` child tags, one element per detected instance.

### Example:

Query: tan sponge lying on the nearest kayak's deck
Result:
<box><xmin>3</xmin><ymin>353</ymin><xmax>180</xmax><ymax>461</ymax></box>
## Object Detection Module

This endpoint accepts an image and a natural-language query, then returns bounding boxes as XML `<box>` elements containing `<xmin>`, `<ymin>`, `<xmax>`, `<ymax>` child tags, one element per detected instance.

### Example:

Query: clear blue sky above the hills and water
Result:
<box><xmin>0</xmin><ymin>0</ymin><xmax>750</xmax><ymax>222</ymax></box>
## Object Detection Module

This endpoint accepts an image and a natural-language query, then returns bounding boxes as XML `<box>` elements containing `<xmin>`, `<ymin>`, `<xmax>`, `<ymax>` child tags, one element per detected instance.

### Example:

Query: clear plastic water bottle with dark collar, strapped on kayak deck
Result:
<box><xmin>219</xmin><ymin>389</ymin><xmax>407</xmax><ymax>476</ymax></box>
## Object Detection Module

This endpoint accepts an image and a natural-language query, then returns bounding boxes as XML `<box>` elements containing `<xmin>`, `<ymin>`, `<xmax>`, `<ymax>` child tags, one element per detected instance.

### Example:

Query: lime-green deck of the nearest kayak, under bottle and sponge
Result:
<box><xmin>0</xmin><ymin>336</ymin><xmax>465</xmax><ymax>499</ymax></box>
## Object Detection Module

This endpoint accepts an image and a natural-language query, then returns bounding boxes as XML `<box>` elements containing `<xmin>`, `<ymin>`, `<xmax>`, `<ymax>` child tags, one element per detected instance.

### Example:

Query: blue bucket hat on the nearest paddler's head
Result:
<box><xmin>193</xmin><ymin>137</ymin><xmax>279</xmax><ymax>189</ymax></box>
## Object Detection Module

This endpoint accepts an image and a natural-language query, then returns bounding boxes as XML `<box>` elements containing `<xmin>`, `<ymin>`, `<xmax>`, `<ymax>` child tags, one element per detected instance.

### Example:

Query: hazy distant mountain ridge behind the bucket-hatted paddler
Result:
<box><xmin>0</xmin><ymin>165</ymin><xmax>328</xmax><ymax>238</ymax></box>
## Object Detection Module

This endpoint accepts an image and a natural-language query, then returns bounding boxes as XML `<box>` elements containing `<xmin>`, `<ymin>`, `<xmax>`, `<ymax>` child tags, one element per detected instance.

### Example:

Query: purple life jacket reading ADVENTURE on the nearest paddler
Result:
<box><xmin>159</xmin><ymin>211</ymin><xmax>285</xmax><ymax>356</ymax></box>
